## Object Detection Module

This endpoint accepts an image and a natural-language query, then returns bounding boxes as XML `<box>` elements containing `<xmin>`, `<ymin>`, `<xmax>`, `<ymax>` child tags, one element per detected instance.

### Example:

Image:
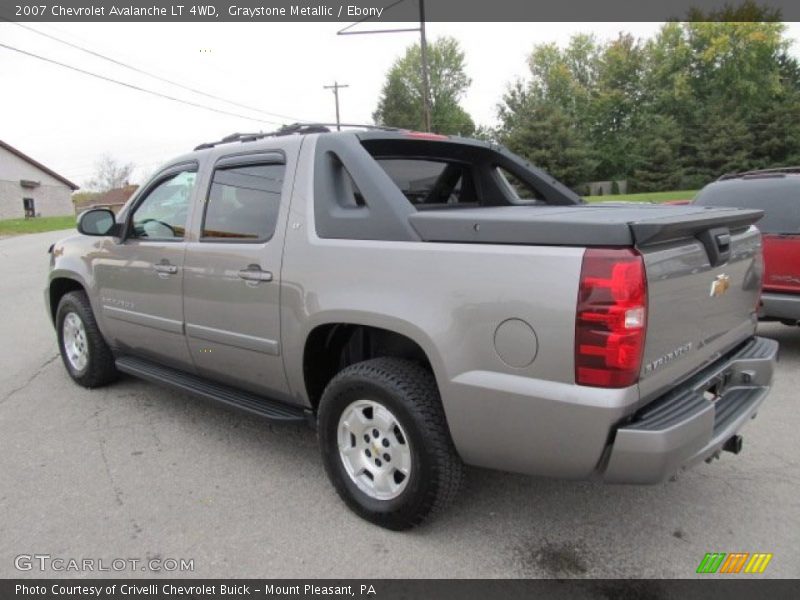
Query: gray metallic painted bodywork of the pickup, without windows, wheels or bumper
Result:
<box><xmin>50</xmin><ymin>134</ymin><xmax>774</xmax><ymax>481</ymax></box>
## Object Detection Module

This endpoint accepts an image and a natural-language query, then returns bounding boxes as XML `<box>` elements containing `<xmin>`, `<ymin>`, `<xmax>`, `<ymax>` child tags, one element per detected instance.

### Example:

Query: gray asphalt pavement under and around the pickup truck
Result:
<box><xmin>0</xmin><ymin>232</ymin><xmax>800</xmax><ymax>578</ymax></box>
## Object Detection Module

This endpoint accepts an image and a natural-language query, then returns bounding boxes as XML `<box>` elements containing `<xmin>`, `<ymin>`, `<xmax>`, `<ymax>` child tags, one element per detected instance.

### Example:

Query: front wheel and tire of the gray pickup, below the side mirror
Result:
<box><xmin>56</xmin><ymin>292</ymin><xmax>119</xmax><ymax>388</ymax></box>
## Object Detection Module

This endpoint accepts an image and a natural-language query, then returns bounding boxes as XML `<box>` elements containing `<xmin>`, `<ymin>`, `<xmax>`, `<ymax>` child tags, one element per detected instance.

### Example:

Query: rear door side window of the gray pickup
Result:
<box><xmin>201</xmin><ymin>164</ymin><xmax>286</xmax><ymax>242</ymax></box>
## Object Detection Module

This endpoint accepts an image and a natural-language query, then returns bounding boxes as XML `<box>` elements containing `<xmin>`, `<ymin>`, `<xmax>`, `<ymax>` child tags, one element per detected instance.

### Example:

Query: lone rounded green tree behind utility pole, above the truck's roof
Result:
<box><xmin>372</xmin><ymin>37</ymin><xmax>475</xmax><ymax>136</ymax></box>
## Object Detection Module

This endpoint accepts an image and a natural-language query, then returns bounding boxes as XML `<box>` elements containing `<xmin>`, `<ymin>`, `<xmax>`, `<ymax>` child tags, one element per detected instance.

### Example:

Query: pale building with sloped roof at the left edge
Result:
<box><xmin>0</xmin><ymin>140</ymin><xmax>78</xmax><ymax>219</ymax></box>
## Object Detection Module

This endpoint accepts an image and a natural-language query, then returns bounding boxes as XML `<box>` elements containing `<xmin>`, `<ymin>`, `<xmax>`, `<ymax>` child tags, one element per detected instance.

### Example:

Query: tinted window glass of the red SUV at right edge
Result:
<box><xmin>694</xmin><ymin>177</ymin><xmax>800</xmax><ymax>233</ymax></box>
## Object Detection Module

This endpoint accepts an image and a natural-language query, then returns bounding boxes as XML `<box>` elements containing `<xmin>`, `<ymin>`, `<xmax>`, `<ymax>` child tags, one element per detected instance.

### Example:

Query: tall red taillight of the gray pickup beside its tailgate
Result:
<box><xmin>575</xmin><ymin>248</ymin><xmax>647</xmax><ymax>388</ymax></box>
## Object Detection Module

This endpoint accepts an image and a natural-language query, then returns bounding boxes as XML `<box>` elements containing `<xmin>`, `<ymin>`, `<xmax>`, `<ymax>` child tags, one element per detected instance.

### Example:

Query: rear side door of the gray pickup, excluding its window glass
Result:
<box><xmin>183</xmin><ymin>143</ymin><xmax>302</xmax><ymax>399</ymax></box>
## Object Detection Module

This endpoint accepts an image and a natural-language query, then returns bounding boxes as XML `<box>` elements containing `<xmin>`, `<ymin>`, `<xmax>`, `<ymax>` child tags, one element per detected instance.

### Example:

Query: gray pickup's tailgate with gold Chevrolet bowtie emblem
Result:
<box><xmin>630</xmin><ymin>209</ymin><xmax>763</xmax><ymax>401</ymax></box>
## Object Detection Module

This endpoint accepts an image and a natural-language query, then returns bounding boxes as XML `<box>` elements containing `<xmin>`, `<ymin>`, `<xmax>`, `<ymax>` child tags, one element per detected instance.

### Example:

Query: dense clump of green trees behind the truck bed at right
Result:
<box><xmin>498</xmin><ymin>17</ymin><xmax>800</xmax><ymax>191</ymax></box>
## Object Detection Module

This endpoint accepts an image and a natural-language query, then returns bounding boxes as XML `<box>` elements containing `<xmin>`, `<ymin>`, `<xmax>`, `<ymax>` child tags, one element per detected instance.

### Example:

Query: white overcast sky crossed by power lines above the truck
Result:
<box><xmin>0</xmin><ymin>23</ymin><xmax>800</xmax><ymax>185</ymax></box>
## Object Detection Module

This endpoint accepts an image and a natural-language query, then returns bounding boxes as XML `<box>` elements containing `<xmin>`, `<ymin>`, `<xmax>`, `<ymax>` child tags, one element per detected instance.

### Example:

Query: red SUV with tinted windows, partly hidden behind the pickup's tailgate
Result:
<box><xmin>693</xmin><ymin>167</ymin><xmax>800</xmax><ymax>325</ymax></box>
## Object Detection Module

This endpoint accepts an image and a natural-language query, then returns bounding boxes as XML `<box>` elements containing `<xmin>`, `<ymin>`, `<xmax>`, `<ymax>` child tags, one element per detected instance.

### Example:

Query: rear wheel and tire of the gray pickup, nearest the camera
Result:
<box><xmin>318</xmin><ymin>358</ymin><xmax>463</xmax><ymax>530</ymax></box>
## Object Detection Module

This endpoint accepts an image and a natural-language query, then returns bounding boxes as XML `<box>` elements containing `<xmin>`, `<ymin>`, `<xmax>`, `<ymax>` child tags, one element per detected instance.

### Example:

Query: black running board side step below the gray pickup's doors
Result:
<box><xmin>115</xmin><ymin>356</ymin><xmax>311</xmax><ymax>423</ymax></box>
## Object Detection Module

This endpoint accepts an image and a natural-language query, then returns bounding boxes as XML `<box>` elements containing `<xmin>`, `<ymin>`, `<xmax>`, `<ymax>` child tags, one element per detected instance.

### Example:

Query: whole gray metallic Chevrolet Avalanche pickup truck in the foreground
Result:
<box><xmin>45</xmin><ymin>125</ymin><xmax>777</xmax><ymax>529</ymax></box>
